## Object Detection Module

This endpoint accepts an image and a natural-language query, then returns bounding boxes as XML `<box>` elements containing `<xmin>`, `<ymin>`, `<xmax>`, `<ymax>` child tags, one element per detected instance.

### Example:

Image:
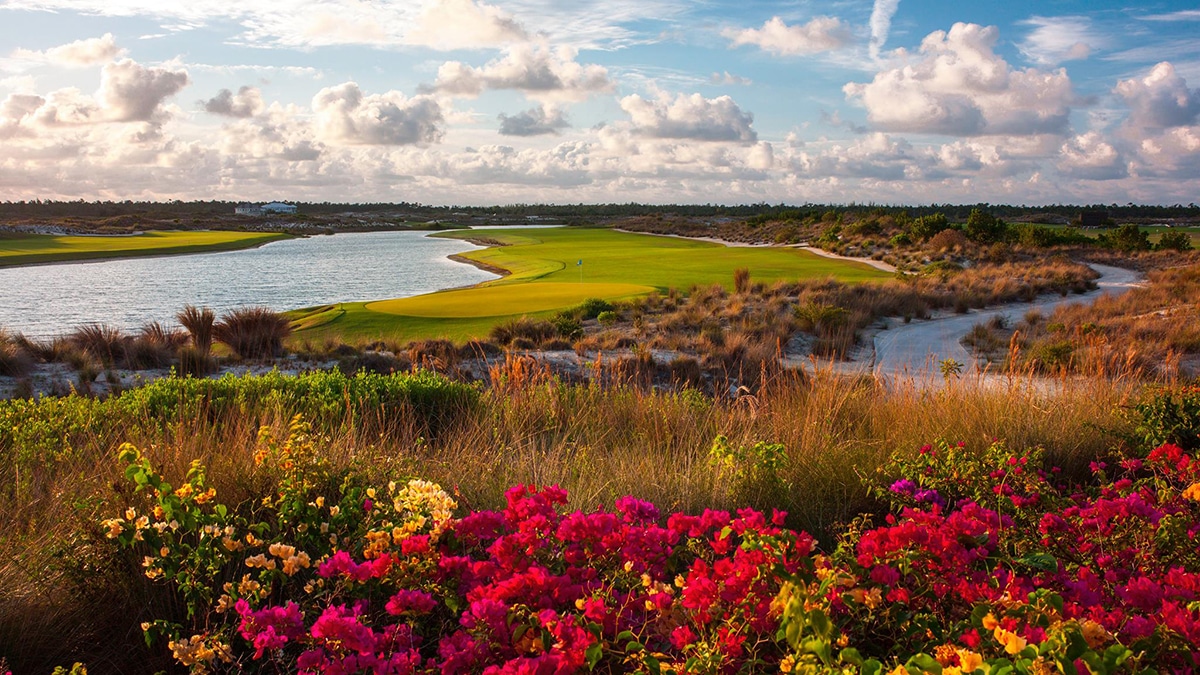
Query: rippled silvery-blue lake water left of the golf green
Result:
<box><xmin>0</xmin><ymin>232</ymin><xmax>496</xmax><ymax>338</ymax></box>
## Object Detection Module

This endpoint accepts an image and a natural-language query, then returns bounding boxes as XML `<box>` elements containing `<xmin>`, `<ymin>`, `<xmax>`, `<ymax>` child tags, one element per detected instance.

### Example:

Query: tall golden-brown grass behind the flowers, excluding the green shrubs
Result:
<box><xmin>0</xmin><ymin>367</ymin><xmax>1136</xmax><ymax>673</ymax></box>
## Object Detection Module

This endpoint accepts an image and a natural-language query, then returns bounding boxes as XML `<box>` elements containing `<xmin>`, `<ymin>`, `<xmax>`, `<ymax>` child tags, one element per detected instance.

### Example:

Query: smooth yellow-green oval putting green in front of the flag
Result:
<box><xmin>366</xmin><ymin>282</ymin><xmax>654</xmax><ymax>318</ymax></box>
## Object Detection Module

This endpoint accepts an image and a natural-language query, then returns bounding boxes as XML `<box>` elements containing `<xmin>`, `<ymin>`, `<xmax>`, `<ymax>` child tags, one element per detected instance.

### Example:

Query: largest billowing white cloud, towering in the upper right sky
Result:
<box><xmin>842</xmin><ymin>23</ymin><xmax>1075</xmax><ymax>136</ymax></box>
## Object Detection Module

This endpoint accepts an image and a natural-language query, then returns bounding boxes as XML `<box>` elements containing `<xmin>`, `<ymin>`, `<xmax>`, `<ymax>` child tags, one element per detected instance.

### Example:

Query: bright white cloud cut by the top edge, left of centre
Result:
<box><xmin>408</xmin><ymin>0</ymin><xmax>529</xmax><ymax>49</ymax></box>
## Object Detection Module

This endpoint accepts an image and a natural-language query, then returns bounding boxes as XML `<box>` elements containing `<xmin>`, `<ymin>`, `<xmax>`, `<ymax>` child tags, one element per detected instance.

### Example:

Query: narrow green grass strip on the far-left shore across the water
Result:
<box><xmin>0</xmin><ymin>231</ymin><xmax>290</xmax><ymax>267</ymax></box>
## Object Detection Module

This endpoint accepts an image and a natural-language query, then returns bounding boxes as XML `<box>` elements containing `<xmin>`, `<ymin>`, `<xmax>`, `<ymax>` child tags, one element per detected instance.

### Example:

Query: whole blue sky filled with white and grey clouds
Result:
<box><xmin>0</xmin><ymin>0</ymin><xmax>1200</xmax><ymax>205</ymax></box>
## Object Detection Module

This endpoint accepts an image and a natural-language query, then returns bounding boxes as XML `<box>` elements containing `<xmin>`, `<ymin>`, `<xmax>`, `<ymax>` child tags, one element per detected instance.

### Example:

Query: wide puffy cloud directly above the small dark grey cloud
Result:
<box><xmin>432</xmin><ymin>43</ymin><xmax>613</xmax><ymax>101</ymax></box>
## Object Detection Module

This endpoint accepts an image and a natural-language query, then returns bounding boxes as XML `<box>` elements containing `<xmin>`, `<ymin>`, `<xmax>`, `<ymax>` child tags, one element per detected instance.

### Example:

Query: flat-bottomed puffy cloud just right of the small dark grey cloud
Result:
<box><xmin>620</xmin><ymin>92</ymin><xmax>758</xmax><ymax>143</ymax></box>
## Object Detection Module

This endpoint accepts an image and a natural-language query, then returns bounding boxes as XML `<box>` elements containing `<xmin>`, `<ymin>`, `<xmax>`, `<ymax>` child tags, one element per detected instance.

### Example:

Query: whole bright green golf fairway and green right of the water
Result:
<box><xmin>289</xmin><ymin>227</ymin><xmax>890</xmax><ymax>341</ymax></box>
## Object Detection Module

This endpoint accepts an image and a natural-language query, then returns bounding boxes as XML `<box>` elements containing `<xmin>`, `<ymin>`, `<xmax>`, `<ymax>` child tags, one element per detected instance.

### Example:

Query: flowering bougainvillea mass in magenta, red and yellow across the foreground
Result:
<box><xmin>102</xmin><ymin>401</ymin><xmax>1200</xmax><ymax>675</ymax></box>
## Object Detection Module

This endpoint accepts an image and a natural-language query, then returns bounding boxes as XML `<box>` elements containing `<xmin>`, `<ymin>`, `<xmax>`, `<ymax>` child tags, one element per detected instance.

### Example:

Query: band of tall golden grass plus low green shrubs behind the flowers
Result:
<box><xmin>0</xmin><ymin>360</ymin><xmax>1133</xmax><ymax>673</ymax></box>
